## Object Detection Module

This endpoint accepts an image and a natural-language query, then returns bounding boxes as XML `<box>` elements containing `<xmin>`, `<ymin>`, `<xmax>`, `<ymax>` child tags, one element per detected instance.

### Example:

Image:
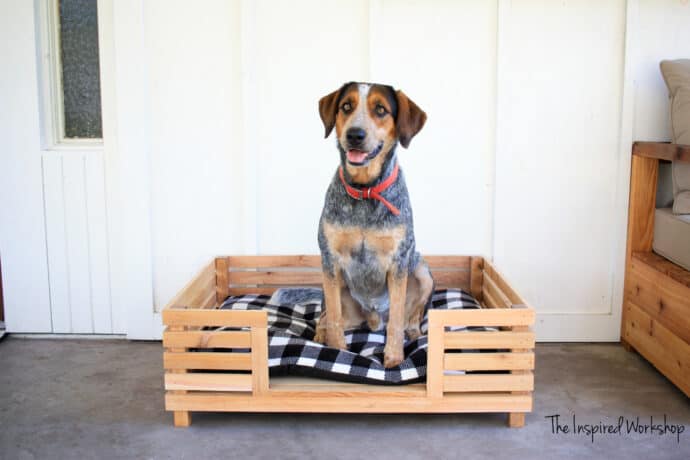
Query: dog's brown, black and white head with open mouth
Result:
<box><xmin>319</xmin><ymin>82</ymin><xmax>426</xmax><ymax>172</ymax></box>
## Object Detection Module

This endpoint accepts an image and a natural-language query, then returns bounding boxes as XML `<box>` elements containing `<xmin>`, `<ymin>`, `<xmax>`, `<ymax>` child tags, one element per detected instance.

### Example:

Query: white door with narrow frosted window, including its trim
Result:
<box><xmin>0</xmin><ymin>0</ymin><xmax>157</xmax><ymax>338</ymax></box>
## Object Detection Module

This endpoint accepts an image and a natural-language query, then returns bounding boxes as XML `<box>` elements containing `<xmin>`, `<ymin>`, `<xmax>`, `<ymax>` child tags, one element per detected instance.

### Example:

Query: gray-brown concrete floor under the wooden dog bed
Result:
<box><xmin>0</xmin><ymin>337</ymin><xmax>690</xmax><ymax>460</ymax></box>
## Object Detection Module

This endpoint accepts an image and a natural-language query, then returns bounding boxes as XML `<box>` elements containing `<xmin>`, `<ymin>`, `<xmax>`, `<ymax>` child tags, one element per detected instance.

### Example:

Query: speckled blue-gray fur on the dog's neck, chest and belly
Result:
<box><xmin>318</xmin><ymin>142</ymin><xmax>420</xmax><ymax>312</ymax></box>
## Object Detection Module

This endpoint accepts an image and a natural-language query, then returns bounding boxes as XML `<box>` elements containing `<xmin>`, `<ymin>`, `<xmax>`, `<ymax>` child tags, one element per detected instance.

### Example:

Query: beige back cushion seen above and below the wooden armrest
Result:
<box><xmin>660</xmin><ymin>59</ymin><xmax>690</xmax><ymax>214</ymax></box>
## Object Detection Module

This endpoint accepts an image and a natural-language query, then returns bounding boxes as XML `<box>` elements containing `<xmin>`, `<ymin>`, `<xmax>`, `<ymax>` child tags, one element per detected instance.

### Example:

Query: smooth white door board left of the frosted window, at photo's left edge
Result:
<box><xmin>0</xmin><ymin>0</ymin><xmax>51</xmax><ymax>332</ymax></box>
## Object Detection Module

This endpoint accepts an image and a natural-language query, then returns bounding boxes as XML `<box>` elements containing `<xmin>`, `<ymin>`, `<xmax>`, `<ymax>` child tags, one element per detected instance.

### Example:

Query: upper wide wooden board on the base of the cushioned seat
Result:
<box><xmin>625</xmin><ymin>258</ymin><xmax>690</xmax><ymax>343</ymax></box>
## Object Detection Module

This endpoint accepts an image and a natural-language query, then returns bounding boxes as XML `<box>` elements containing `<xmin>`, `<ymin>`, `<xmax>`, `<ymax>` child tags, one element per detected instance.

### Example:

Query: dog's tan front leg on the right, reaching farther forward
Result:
<box><xmin>383</xmin><ymin>270</ymin><xmax>407</xmax><ymax>368</ymax></box>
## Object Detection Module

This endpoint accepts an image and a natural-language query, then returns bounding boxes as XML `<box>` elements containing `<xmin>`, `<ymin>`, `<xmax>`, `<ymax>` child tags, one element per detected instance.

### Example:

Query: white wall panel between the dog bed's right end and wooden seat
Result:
<box><xmin>494</xmin><ymin>1</ymin><xmax>625</xmax><ymax>340</ymax></box>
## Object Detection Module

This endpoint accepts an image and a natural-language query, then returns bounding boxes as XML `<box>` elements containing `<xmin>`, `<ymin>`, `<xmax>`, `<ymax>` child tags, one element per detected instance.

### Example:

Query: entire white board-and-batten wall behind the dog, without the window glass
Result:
<box><xmin>0</xmin><ymin>0</ymin><xmax>690</xmax><ymax>340</ymax></box>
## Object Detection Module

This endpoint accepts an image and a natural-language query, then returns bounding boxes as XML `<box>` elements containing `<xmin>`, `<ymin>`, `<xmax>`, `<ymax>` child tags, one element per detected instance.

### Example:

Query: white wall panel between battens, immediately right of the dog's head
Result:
<box><xmin>369</xmin><ymin>0</ymin><xmax>496</xmax><ymax>256</ymax></box>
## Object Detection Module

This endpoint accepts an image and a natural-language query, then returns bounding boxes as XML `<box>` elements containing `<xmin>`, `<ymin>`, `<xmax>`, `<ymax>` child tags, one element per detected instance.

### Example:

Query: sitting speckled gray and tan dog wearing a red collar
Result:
<box><xmin>315</xmin><ymin>82</ymin><xmax>434</xmax><ymax>368</ymax></box>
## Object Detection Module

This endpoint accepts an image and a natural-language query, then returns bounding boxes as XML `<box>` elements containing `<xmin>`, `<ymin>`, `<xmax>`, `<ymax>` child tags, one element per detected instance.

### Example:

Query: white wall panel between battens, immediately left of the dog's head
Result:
<box><xmin>250</xmin><ymin>0</ymin><xmax>369</xmax><ymax>254</ymax></box>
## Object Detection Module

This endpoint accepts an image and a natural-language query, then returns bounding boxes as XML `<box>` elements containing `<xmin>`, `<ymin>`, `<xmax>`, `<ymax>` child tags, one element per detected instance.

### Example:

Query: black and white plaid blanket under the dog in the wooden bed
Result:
<box><xmin>220</xmin><ymin>289</ymin><xmax>489</xmax><ymax>384</ymax></box>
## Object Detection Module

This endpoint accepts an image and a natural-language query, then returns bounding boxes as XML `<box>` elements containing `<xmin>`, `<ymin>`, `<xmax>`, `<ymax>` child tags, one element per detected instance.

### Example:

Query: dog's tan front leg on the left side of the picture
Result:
<box><xmin>314</xmin><ymin>268</ymin><xmax>347</xmax><ymax>350</ymax></box>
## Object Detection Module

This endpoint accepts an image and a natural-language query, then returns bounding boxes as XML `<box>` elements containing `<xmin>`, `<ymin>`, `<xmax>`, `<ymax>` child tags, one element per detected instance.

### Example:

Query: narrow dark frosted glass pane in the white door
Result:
<box><xmin>60</xmin><ymin>0</ymin><xmax>103</xmax><ymax>139</ymax></box>
